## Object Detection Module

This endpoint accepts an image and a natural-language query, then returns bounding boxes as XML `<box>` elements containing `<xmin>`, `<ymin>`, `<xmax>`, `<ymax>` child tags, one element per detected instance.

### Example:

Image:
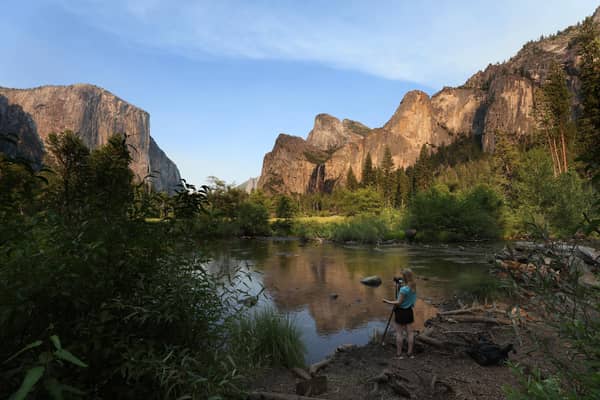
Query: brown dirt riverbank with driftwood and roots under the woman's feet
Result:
<box><xmin>245</xmin><ymin>242</ymin><xmax>600</xmax><ymax>399</ymax></box>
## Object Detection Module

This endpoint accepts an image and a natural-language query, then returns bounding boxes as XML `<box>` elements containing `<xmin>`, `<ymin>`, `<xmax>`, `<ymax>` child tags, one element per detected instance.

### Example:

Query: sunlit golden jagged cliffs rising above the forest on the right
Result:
<box><xmin>258</xmin><ymin>7</ymin><xmax>600</xmax><ymax>194</ymax></box>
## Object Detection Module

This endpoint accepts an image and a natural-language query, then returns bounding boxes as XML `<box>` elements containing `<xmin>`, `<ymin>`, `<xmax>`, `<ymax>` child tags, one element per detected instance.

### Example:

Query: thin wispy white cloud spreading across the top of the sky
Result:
<box><xmin>55</xmin><ymin>0</ymin><xmax>594</xmax><ymax>85</ymax></box>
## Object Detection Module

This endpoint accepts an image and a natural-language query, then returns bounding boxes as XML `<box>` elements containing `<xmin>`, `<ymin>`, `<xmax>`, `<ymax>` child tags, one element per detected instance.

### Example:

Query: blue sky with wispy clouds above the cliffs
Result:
<box><xmin>0</xmin><ymin>0</ymin><xmax>599</xmax><ymax>183</ymax></box>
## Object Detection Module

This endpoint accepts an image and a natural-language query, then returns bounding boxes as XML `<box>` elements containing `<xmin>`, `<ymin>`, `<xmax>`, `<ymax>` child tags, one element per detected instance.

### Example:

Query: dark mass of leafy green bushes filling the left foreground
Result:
<box><xmin>0</xmin><ymin>132</ymin><xmax>292</xmax><ymax>398</ymax></box>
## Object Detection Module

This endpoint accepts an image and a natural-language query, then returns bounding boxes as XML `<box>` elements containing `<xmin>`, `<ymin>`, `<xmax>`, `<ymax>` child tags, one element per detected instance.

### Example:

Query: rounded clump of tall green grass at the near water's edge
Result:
<box><xmin>230</xmin><ymin>308</ymin><xmax>306</xmax><ymax>368</ymax></box>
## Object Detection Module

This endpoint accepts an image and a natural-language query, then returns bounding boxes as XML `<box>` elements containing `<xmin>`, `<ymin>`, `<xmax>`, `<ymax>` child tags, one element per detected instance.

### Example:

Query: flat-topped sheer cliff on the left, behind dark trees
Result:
<box><xmin>0</xmin><ymin>84</ymin><xmax>179</xmax><ymax>192</ymax></box>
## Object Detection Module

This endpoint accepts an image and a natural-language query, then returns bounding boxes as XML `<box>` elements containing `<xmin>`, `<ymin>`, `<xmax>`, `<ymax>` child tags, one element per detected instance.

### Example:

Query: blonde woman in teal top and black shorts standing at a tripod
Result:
<box><xmin>383</xmin><ymin>268</ymin><xmax>417</xmax><ymax>359</ymax></box>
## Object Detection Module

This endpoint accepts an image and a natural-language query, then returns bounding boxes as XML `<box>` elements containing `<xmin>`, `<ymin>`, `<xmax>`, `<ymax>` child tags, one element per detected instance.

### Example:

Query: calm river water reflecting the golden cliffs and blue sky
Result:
<box><xmin>210</xmin><ymin>240</ymin><xmax>501</xmax><ymax>363</ymax></box>
